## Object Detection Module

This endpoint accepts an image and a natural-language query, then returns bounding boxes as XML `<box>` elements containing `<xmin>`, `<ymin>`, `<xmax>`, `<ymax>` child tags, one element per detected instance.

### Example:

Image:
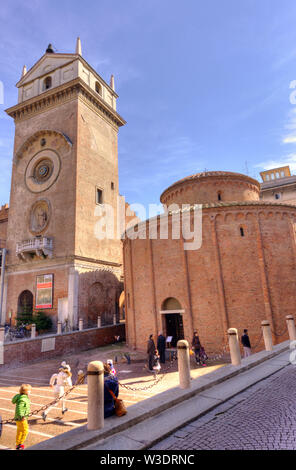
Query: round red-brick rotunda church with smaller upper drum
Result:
<box><xmin>123</xmin><ymin>171</ymin><xmax>296</xmax><ymax>353</ymax></box>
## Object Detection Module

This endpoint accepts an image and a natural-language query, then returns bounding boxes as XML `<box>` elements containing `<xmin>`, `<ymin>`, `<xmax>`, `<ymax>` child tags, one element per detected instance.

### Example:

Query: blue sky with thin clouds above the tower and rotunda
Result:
<box><xmin>0</xmin><ymin>0</ymin><xmax>296</xmax><ymax>213</ymax></box>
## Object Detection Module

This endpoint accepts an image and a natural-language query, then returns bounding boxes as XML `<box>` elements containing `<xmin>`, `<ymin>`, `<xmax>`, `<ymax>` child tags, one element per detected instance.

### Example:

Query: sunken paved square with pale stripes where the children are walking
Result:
<box><xmin>0</xmin><ymin>343</ymin><xmax>225</xmax><ymax>451</ymax></box>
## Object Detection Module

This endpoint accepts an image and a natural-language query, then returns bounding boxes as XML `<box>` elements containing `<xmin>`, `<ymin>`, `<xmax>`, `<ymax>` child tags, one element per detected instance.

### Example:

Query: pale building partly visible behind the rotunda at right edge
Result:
<box><xmin>260</xmin><ymin>166</ymin><xmax>296</xmax><ymax>204</ymax></box>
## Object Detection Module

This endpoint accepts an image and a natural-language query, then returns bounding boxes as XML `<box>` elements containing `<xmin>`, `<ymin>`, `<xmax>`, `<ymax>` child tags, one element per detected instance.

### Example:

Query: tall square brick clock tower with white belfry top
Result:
<box><xmin>0</xmin><ymin>39</ymin><xmax>129</xmax><ymax>327</ymax></box>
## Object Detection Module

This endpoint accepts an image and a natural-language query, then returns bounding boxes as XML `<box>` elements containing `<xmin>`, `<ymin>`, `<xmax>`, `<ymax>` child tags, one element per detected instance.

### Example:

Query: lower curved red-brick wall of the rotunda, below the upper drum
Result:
<box><xmin>124</xmin><ymin>201</ymin><xmax>296</xmax><ymax>353</ymax></box>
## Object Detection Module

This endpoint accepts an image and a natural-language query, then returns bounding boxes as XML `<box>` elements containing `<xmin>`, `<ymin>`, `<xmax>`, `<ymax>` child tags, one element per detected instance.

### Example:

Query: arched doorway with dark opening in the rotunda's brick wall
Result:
<box><xmin>161</xmin><ymin>297</ymin><xmax>184</xmax><ymax>347</ymax></box>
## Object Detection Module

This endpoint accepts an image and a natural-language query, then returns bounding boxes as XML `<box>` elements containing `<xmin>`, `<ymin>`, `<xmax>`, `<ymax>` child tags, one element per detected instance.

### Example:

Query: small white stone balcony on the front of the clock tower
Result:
<box><xmin>16</xmin><ymin>237</ymin><xmax>53</xmax><ymax>261</ymax></box>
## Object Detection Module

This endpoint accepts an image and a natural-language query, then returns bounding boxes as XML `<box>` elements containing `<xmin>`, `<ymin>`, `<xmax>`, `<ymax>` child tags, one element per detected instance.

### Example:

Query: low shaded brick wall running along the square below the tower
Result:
<box><xmin>0</xmin><ymin>324</ymin><xmax>125</xmax><ymax>372</ymax></box>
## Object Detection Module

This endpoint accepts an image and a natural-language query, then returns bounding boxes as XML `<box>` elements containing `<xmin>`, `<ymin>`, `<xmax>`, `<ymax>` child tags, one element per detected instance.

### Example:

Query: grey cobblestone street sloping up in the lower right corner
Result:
<box><xmin>152</xmin><ymin>365</ymin><xmax>296</xmax><ymax>450</ymax></box>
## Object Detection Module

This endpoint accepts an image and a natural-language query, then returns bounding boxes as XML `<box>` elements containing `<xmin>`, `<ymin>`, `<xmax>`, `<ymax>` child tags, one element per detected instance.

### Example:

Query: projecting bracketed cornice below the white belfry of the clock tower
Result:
<box><xmin>5</xmin><ymin>78</ymin><xmax>126</xmax><ymax>128</ymax></box>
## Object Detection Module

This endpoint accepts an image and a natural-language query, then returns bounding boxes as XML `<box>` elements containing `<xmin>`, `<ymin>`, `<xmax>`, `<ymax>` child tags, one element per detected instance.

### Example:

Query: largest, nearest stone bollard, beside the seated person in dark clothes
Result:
<box><xmin>87</xmin><ymin>361</ymin><xmax>104</xmax><ymax>431</ymax></box>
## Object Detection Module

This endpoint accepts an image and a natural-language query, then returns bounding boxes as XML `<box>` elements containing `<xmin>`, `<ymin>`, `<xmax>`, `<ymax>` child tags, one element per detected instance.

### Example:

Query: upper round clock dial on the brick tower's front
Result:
<box><xmin>25</xmin><ymin>149</ymin><xmax>61</xmax><ymax>193</ymax></box>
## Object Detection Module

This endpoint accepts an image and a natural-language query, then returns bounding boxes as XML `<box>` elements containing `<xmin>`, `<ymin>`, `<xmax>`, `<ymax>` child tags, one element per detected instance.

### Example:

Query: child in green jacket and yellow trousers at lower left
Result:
<box><xmin>11</xmin><ymin>384</ymin><xmax>32</xmax><ymax>450</ymax></box>
